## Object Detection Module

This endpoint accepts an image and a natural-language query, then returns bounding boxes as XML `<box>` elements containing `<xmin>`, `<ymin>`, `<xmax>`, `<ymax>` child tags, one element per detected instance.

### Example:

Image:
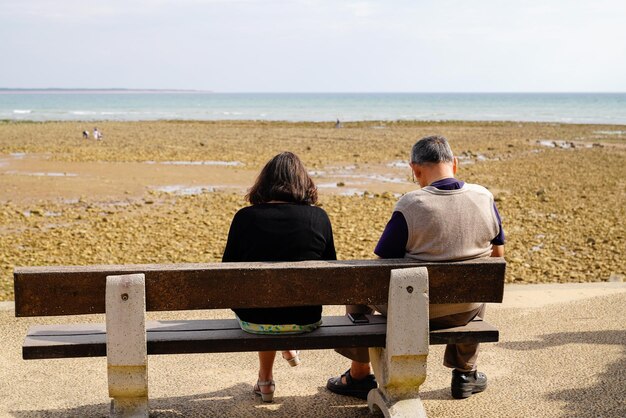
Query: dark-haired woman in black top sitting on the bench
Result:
<box><xmin>222</xmin><ymin>152</ymin><xmax>337</xmax><ymax>402</ymax></box>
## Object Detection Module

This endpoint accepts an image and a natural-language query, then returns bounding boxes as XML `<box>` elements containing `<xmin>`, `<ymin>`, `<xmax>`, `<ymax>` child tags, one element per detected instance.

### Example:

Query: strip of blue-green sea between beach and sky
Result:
<box><xmin>0</xmin><ymin>89</ymin><xmax>626</xmax><ymax>125</ymax></box>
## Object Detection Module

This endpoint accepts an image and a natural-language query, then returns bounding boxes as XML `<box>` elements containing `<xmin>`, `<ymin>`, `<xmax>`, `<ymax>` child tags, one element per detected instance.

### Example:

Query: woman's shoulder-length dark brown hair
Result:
<box><xmin>246</xmin><ymin>151</ymin><xmax>317</xmax><ymax>205</ymax></box>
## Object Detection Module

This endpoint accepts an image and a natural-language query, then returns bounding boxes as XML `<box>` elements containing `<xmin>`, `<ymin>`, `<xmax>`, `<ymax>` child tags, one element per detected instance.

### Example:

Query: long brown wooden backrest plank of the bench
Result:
<box><xmin>13</xmin><ymin>258</ymin><xmax>506</xmax><ymax>317</ymax></box>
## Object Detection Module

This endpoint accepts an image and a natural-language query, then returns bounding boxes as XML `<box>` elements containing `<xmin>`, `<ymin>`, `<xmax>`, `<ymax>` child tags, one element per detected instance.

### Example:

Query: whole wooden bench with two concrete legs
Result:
<box><xmin>14</xmin><ymin>258</ymin><xmax>506</xmax><ymax>416</ymax></box>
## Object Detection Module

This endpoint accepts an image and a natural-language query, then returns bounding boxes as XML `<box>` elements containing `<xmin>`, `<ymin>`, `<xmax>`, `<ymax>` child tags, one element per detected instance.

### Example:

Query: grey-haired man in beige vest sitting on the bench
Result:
<box><xmin>326</xmin><ymin>136</ymin><xmax>504</xmax><ymax>399</ymax></box>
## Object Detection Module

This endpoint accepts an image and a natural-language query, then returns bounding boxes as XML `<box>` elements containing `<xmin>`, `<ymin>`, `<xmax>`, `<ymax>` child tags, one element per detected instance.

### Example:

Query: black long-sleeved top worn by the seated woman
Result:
<box><xmin>222</xmin><ymin>203</ymin><xmax>337</xmax><ymax>325</ymax></box>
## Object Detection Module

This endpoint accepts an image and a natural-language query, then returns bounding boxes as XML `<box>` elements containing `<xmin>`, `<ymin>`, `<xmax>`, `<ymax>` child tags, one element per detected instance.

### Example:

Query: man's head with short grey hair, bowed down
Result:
<box><xmin>411</xmin><ymin>135</ymin><xmax>457</xmax><ymax>187</ymax></box>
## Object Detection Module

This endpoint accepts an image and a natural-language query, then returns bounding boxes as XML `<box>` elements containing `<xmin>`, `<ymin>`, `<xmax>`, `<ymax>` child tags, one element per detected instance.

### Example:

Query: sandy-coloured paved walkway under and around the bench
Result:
<box><xmin>0</xmin><ymin>283</ymin><xmax>626</xmax><ymax>418</ymax></box>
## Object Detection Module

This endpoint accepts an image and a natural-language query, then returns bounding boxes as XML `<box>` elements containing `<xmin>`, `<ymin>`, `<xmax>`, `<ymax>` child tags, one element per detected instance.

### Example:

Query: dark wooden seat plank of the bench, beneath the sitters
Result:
<box><xmin>22</xmin><ymin>315</ymin><xmax>498</xmax><ymax>360</ymax></box>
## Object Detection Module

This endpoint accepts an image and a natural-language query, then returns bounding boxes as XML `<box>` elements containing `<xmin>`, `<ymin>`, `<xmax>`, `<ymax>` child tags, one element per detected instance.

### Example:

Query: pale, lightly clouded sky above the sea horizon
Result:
<box><xmin>0</xmin><ymin>0</ymin><xmax>626</xmax><ymax>92</ymax></box>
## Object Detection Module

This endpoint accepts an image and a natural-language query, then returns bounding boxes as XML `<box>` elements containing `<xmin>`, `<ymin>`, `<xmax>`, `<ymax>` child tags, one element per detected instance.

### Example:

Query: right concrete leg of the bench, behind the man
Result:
<box><xmin>367</xmin><ymin>267</ymin><xmax>429</xmax><ymax>417</ymax></box>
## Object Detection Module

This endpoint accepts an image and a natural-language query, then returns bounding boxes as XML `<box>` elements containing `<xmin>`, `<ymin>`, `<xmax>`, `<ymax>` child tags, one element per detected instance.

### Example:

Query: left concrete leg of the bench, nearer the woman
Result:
<box><xmin>106</xmin><ymin>274</ymin><xmax>148</xmax><ymax>418</ymax></box>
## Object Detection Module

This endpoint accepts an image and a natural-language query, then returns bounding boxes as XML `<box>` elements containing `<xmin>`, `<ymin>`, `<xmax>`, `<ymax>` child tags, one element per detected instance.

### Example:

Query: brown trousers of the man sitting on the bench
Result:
<box><xmin>335</xmin><ymin>304</ymin><xmax>485</xmax><ymax>372</ymax></box>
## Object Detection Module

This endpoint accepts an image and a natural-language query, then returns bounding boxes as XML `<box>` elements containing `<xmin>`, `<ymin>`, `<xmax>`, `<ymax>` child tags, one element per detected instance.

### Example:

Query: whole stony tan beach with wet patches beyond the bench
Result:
<box><xmin>0</xmin><ymin>122</ymin><xmax>626</xmax><ymax>300</ymax></box>
